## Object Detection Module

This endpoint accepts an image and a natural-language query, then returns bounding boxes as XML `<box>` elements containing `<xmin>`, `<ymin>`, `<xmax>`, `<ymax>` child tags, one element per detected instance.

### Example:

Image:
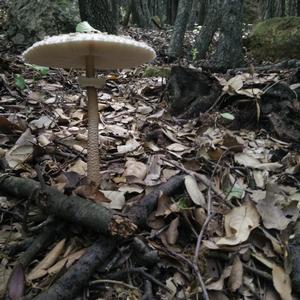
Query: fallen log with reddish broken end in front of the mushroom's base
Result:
<box><xmin>0</xmin><ymin>175</ymin><xmax>136</xmax><ymax>237</ymax></box>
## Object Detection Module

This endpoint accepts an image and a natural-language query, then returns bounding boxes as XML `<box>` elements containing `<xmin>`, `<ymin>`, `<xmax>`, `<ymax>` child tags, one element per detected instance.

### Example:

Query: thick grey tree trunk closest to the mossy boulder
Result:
<box><xmin>213</xmin><ymin>0</ymin><xmax>243</xmax><ymax>70</ymax></box>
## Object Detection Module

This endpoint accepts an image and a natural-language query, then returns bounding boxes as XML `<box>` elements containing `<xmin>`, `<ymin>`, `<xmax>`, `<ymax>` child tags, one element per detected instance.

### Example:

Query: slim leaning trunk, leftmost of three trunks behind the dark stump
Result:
<box><xmin>168</xmin><ymin>0</ymin><xmax>193</xmax><ymax>57</ymax></box>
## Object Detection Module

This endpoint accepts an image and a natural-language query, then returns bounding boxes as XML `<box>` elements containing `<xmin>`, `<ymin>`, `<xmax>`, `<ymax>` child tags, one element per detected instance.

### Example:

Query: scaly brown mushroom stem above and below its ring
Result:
<box><xmin>85</xmin><ymin>56</ymin><xmax>100</xmax><ymax>185</ymax></box>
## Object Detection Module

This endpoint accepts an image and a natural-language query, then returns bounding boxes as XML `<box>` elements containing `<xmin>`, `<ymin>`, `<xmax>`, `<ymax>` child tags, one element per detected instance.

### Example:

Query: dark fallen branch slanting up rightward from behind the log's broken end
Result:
<box><xmin>125</xmin><ymin>175</ymin><xmax>184</xmax><ymax>226</ymax></box>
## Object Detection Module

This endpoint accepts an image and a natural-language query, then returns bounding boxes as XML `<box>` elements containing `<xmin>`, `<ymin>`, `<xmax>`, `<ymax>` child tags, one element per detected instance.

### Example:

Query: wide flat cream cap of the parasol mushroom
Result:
<box><xmin>23</xmin><ymin>33</ymin><xmax>155</xmax><ymax>70</ymax></box>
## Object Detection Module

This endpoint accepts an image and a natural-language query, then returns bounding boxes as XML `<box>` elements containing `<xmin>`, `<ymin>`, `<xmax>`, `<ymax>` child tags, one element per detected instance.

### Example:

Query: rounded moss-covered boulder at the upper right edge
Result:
<box><xmin>249</xmin><ymin>17</ymin><xmax>300</xmax><ymax>59</ymax></box>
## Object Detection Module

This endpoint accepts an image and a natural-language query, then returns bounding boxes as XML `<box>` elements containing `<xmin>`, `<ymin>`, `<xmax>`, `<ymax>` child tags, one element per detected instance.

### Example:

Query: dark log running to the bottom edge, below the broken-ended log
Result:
<box><xmin>34</xmin><ymin>237</ymin><xmax>116</xmax><ymax>300</ymax></box>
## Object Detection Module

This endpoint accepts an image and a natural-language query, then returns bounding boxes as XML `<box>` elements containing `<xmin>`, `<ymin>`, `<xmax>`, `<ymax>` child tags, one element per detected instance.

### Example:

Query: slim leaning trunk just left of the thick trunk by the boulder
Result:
<box><xmin>195</xmin><ymin>0</ymin><xmax>223</xmax><ymax>59</ymax></box>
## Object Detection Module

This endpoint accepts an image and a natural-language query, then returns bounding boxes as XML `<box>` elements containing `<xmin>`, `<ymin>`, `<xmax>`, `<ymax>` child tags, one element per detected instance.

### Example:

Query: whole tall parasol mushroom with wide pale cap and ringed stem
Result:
<box><xmin>23</xmin><ymin>27</ymin><xmax>155</xmax><ymax>185</ymax></box>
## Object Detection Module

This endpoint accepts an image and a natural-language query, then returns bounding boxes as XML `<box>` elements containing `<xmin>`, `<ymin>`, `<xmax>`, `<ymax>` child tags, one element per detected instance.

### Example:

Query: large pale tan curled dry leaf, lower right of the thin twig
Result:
<box><xmin>217</xmin><ymin>201</ymin><xmax>260</xmax><ymax>246</ymax></box>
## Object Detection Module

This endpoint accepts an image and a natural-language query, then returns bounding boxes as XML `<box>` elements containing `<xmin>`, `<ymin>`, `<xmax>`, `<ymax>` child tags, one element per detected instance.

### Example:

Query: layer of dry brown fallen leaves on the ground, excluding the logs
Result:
<box><xmin>0</xmin><ymin>27</ymin><xmax>300</xmax><ymax>300</ymax></box>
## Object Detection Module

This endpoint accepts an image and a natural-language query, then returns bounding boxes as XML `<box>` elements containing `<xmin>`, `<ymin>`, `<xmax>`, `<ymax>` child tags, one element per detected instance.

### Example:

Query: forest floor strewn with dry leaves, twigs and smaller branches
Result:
<box><xmin>0</xmin><ymin>29</ymin><xmax>300</xmax><ymax>300</ymax></box>
